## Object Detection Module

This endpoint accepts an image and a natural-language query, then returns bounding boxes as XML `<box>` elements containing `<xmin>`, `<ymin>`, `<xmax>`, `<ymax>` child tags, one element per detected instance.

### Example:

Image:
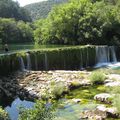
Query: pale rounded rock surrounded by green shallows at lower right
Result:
<box><xmin>94</xmin><ymin>93</ymin><xmax>113</xmax><ymax>103</ymax></box>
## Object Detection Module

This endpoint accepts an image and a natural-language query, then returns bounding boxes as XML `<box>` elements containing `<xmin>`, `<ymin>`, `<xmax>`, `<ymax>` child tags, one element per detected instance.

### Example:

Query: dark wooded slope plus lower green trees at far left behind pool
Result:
<box><xmin>0</xmin><ymin>0</ymin><xmax>33</xmax><ymax>44</ymax></box>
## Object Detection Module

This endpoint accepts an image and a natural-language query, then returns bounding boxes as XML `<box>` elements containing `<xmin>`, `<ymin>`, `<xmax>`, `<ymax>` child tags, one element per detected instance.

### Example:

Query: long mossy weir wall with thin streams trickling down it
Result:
<box><xmin>0</xmin><ymin>46</ymin><xmax>119</xmax><ymax>75</ymax></box>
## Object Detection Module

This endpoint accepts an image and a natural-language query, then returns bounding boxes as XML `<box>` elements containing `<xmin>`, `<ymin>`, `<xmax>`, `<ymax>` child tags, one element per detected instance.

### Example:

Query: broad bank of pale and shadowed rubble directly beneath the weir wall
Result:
<box><xmin>0</xmin><ymin>70</ymin><xmax>90</xmax><ymax>99</ymax></box>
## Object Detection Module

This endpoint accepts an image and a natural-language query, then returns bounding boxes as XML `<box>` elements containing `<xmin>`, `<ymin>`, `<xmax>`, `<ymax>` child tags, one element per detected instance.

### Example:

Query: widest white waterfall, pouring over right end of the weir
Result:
<box><xmin>95</xmin><ymin>46</ymin><xmax>117</xmax><ymax>67</ymax></box>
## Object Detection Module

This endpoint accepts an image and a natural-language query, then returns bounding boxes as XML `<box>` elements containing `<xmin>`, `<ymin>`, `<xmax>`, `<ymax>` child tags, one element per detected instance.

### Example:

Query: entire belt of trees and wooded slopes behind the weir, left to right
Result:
<box><xmin>0</xmin><ymin>0</ymin><xmax>120</xmax><ymax>45</ymax></box>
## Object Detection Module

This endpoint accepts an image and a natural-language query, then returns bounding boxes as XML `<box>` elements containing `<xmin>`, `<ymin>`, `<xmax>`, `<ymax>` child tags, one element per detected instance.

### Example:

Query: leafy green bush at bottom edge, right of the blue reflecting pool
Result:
<box><xmin>19</xmin><ymin>101</ymin><xmax>55</xmax><ymax>120</ymax></box>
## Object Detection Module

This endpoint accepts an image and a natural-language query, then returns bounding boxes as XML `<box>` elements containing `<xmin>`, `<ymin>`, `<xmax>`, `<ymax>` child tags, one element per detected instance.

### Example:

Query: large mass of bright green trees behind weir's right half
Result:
<box><xmin>34</xmin><ymin>0</ymin><xmax>120</xmax><ymax>45</ymax></box>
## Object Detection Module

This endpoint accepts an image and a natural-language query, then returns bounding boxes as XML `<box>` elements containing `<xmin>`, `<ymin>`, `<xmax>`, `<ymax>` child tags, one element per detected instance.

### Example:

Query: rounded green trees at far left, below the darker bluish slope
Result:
<box><xmin>0</xmin><ymin>18</ymin><xmax>33</xmax><ymax>44</ymax></box>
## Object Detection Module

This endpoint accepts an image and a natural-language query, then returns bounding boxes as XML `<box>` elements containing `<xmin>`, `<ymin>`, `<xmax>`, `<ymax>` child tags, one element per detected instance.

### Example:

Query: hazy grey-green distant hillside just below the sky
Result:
<box><xmin>24</xmin><ymin>0</ymin><xmax>68</xmax><ymax>21</ymax></box>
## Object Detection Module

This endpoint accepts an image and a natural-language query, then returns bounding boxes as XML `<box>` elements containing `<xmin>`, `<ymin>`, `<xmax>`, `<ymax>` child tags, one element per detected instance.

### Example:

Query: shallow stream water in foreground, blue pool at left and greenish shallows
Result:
<box><xmin>1</xmin><ymin>86</ymin><xmax>105</xmax><ymax>120</ymax></box>
